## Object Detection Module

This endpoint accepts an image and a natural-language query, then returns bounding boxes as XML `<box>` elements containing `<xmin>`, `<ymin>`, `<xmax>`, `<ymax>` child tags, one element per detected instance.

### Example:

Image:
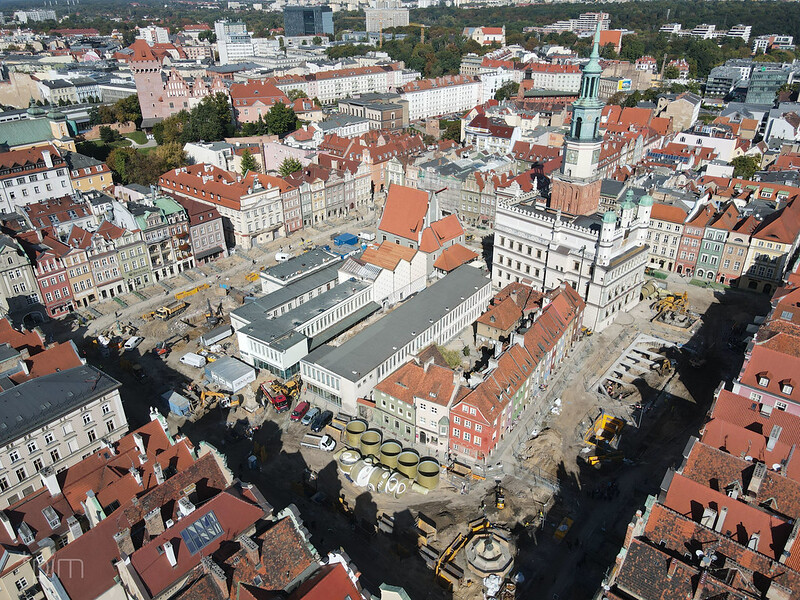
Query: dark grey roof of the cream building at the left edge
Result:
<box><xmin>0</xmin><ymin>365</ymin><xmax>122</xmax><ymax>445</ymax></box>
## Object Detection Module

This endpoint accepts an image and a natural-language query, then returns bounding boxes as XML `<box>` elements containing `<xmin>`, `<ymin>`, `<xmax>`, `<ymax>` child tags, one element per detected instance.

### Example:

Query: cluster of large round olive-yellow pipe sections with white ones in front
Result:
<box><xmin>337</xmin><ymin>419</ymin><xmax>439</xmax><ymax>498</ymax></box>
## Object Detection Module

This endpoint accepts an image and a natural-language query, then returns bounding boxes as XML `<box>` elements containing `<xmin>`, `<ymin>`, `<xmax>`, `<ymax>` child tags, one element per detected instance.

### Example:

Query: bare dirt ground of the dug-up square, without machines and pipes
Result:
<box><xmin>50</xmin><ymin>226</ymin><xmax>768</xmax><ymax>600</ymax></box>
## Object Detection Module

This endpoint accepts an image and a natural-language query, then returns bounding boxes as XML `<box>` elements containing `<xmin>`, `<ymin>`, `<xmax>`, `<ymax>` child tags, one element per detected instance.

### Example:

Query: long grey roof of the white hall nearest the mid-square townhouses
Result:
<box><xmin>304</xmin><ymin>265</ymin><xmax>490</xmax><ymax>381</ymax></box>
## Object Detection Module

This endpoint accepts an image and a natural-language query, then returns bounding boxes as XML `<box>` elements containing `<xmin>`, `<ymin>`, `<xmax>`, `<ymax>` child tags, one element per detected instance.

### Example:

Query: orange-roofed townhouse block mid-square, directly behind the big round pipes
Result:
<box><xmin>359</xmin><ymin>283</ymin><xmax>585</xmax><ymax>463</ymax></box>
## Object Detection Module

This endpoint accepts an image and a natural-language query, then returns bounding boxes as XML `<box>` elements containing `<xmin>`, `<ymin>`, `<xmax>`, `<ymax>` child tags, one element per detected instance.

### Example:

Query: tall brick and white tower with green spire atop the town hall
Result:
<box><xmin>550</xmin><ymin>24</ymin><xmax>605</xmax><ymax>215</ymax></box>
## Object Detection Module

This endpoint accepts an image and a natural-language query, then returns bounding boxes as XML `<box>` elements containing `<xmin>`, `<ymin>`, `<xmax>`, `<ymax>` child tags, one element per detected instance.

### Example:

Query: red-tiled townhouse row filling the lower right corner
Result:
<box><xmin>595</xmin><ymin>262</ymin><xmax>800</xmax><ymax>600</ymax></box>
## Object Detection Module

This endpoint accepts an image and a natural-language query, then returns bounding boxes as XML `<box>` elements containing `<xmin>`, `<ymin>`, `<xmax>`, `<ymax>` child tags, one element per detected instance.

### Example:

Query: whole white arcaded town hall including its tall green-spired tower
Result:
<box><xmin>492</xmin><ymin>27</ymin><xmax>653</xmax><ymax>331</ymax></box>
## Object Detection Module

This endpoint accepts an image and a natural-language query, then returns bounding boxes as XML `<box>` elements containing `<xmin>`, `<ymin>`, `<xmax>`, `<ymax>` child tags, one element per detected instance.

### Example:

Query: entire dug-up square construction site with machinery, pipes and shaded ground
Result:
<box><xmin>57</xmin><ymin>245</ymin><xmax>765</xmax><ymax>600</ymax></box>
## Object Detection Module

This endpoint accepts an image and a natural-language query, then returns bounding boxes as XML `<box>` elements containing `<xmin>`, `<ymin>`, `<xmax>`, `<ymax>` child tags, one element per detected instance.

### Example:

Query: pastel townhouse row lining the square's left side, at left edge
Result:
<box><xmin>0</xmin><ymin>193</ymin><xmax>227</xmax><ymax>325</ymax></box>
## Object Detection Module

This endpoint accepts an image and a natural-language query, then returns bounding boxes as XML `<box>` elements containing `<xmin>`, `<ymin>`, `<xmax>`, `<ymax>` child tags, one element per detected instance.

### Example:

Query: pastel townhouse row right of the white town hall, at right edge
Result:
<box><xmin>647</xmin><ymin>177</ymin><xmax>800</xmax><ymax>293</ymax></box>
